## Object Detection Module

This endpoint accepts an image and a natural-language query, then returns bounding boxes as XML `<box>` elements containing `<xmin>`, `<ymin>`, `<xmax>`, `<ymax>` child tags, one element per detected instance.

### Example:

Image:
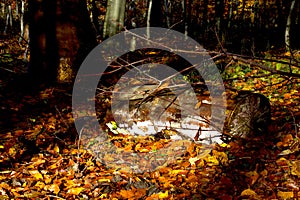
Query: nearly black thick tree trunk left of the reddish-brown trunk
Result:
<box><xmin>29</xmin><ymin>0</ymin><xmax>59</xmax><ymax>83</ymax></box>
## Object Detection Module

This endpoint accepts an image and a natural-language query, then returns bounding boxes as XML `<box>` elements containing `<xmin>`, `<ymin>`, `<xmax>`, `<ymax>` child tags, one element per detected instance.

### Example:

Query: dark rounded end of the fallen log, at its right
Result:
<box><xmin>226</xmin><ymin>91</ymin><xmax>271</xmax><ymax>139</ymax></box>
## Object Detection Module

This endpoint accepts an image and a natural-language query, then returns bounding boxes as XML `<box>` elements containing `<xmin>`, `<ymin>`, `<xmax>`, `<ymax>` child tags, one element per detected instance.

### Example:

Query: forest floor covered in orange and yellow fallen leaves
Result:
<box><xmin>0</xmin><ymin>36</ymin><xmax>300</xmax><ymax>199</ymax></box>
